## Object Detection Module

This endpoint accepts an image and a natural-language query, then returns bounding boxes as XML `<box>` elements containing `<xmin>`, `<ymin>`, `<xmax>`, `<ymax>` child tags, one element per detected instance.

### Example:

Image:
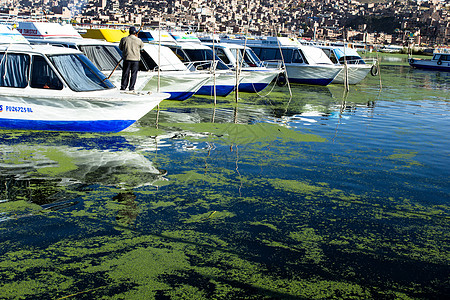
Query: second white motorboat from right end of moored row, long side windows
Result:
<box><xmin>220</xmin><ymin>37</ymin><xmax>342</xmax><ymax>85</ymax></box>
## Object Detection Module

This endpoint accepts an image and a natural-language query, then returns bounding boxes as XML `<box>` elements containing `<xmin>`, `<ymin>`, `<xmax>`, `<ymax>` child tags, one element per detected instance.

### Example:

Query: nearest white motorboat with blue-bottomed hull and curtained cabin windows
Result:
<box><xmin>0</xmin><ymin>25</ymin><xmax>169</xmax><ymax>132</ymax></box>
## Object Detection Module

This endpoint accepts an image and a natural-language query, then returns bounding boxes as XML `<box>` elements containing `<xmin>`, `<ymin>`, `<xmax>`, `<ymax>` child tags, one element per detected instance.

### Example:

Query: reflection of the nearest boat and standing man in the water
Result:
<box><xmin>0</xmin><ymin>133</ymin><xmax>167</xmax><ymax>224</ymax></box>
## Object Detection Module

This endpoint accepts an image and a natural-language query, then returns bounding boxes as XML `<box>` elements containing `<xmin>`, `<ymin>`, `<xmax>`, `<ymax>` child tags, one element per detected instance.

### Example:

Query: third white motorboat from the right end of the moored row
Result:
<box><xmin>203</xmin><ymin>42</ymin><xmax>284</xmax><ymax>93</ymax></box>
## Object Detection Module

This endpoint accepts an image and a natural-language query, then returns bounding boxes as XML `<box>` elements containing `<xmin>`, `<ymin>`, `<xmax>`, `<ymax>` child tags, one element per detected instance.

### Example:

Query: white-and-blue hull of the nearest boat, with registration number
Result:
<box><xmin>0</xmin><ymin>88</ymin><xmax>169</xmax><ymax>132</ymax></box>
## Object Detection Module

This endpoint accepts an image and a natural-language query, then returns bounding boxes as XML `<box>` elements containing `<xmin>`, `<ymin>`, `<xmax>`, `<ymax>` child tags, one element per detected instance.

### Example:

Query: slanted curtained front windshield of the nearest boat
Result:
<box><xmin>48</xmin><ymin>54</ymin><xmax>114</xmax><ymax>92</ymax></box>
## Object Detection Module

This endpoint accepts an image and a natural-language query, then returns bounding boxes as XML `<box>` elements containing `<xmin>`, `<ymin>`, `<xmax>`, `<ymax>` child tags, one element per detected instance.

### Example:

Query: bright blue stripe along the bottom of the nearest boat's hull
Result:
<box><xmin>0</xmin><ymin>119</ymin><xmax>136</xmax><ymax>132</ymax></box>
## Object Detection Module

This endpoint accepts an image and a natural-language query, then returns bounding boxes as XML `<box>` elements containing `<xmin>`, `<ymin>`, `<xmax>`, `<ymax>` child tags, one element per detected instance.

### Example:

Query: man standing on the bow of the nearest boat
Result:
<box><xmin>119</xmin><ymin>26</ymin><xmax>144</xmax><ymax>91</ymax></box>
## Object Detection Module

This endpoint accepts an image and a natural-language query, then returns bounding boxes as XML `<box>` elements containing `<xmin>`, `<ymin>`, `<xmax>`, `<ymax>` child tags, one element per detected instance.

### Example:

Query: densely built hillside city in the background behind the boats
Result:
<box><xmin>0</xmin><ymin>0</ymin><xmax>450</xmax><ymax>46</ymax></box>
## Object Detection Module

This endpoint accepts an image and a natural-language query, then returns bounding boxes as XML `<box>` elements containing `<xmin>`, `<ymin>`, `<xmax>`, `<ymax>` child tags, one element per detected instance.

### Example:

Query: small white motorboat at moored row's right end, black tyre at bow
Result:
<box><xmin>316</xmin><ymin>45</ymin><xmax>378</xmax><ymax>84</ymax></box>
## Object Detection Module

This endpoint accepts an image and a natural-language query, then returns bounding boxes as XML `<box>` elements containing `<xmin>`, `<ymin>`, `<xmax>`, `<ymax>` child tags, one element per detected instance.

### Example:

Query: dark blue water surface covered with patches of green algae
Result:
<box><xmin>0</xmin><ymin>65</ymin><xmax>450</xmax><ymax>299</ymax></box>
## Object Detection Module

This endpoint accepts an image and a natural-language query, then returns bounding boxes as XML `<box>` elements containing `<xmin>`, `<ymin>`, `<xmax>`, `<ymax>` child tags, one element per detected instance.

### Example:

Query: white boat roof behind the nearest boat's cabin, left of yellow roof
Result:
<box><xmin>17</xmin><ymin>22</ymin><xmax>82</xmax><ymax>39</ymax></box>
